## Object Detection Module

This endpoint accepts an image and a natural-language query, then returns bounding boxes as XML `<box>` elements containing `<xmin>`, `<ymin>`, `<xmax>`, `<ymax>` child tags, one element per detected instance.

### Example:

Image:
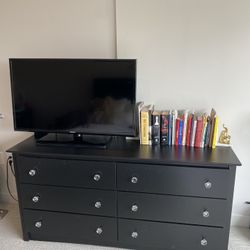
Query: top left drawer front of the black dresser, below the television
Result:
<box><xmin>17</xmin><ymin>156</ymin><xmax>115</xmax><ymax>189</ymax></box>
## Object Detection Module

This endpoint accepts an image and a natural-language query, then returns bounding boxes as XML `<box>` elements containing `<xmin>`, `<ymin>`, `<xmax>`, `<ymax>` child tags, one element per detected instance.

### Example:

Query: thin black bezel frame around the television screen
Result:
<box><xmin>9</xmin><ymin>58</ymin><xmax>137</xmax><ymax>137</ymax></box>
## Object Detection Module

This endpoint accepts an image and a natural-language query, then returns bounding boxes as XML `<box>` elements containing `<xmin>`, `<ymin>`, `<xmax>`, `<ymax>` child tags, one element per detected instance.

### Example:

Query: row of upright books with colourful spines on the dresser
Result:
<box><xmin>138</xmin><ymin>103</ymin><xmax>218</xmax><ymax>148</ymax></box>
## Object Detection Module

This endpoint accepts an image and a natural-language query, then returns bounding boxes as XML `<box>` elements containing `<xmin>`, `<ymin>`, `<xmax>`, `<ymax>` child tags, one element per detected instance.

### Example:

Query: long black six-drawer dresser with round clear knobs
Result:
<box><xmin>9</xmin><ymin>137</ymin><xmax>241</xmax><ymax>250</ymax></box>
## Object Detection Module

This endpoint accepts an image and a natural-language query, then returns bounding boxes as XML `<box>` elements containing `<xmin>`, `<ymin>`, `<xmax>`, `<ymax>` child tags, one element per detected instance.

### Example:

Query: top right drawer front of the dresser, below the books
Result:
<box><xmin>117</xmin><ymin>163</ymin><xmax>230</xmax><ymax>198</ymax></box>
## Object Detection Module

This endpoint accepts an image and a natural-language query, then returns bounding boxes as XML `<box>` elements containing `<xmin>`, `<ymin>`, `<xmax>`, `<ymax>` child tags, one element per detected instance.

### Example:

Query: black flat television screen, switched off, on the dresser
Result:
<box><xmin>9</xmin><ymin>59</ymin><xmax>136</xmax><ymax>136</ymax></box>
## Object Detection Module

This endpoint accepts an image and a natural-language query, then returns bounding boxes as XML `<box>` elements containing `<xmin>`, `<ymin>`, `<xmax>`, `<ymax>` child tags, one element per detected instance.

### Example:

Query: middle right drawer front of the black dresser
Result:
<box><xmin>118</xmin><ymin>192</ymin><xmax>227</xmax><ymax>227</ymax></box>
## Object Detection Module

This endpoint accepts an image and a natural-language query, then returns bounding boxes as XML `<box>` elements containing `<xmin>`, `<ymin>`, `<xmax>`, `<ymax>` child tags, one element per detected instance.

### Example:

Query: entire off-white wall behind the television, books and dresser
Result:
<box><xmin>0</xmin><ymin>0</ymin><xmax>250</xmax><ymax>226</ymax></box>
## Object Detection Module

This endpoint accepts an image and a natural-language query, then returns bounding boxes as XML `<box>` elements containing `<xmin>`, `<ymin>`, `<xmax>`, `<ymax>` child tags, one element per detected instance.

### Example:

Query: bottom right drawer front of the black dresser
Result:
<box><xmin>118</xmin><ymin>219</ymin><xmax>227</xmax><ymax>250</ymax></box>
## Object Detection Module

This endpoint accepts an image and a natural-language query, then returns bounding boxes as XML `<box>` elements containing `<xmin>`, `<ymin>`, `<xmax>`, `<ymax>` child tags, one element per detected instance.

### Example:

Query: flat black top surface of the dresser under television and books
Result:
<box><xmin>8</xmin><ymin>136</ymin><xmax>241</xmax><ymax>168</ymax></box>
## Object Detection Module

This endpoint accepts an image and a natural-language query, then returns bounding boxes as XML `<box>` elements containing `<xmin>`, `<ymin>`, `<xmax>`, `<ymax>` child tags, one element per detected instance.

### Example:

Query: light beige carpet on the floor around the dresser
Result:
<box><xmin>0</xmin><ymin>204</ymin><xmax>250</xmax><ymax>250</ymax></box>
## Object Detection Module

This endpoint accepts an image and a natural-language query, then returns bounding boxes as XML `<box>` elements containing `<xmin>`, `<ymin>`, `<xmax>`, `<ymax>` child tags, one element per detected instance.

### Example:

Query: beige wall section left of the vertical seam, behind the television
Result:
<box><xmin>0</xmin><ymin>0</ymin><xmax>115</xmax><ymax>199</ymax></box>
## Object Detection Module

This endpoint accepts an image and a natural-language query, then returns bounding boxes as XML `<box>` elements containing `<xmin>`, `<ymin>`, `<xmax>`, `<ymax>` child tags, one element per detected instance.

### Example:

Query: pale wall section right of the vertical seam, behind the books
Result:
<box><xmin>117</xmin><ymin>0</ymin><xmax>250</xmax><ymax>226</ymax></box>
